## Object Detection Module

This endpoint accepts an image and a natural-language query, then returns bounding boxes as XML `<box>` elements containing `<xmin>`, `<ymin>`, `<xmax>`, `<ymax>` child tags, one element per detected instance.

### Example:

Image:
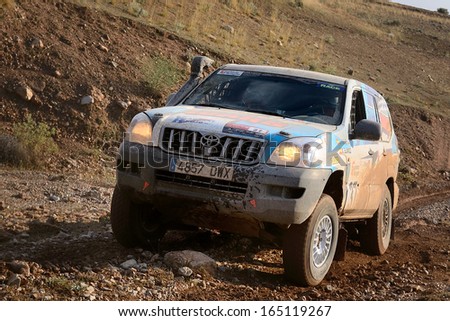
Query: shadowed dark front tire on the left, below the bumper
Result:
<box><xmin>111</xmin><ymin>186</ymin><xmax>166</xmax><ymax>250</ymax></box>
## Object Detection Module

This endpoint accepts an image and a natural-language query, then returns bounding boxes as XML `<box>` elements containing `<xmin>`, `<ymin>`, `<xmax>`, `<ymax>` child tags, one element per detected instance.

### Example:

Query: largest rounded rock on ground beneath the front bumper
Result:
<box><xmin>164</xmin><ymin>250</ymin><xmax>217</xmax><ymax>274</ymax></box>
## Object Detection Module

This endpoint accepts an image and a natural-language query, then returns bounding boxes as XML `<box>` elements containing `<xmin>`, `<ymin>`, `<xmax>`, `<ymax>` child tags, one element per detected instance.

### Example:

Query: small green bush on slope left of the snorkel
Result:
<box><xmin>142</xmin><ymin>56</ymin><xmax>182</xmax><ymax>98</ymax></box>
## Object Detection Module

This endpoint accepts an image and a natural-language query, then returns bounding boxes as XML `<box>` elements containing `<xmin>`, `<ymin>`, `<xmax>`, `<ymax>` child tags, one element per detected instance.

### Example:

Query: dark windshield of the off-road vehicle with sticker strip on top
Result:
<box><xmin>183</xmin><ymin>70</ymin><xmax>345</xmax><ymax>125</ymax></box>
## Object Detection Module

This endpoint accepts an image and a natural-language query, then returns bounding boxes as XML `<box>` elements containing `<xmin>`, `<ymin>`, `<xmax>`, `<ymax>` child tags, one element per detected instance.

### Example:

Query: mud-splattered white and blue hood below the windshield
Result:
<box><xmin>145</xmin><ymin>105</ymin><xmax>336</xmax><ymax>141</ymax></box>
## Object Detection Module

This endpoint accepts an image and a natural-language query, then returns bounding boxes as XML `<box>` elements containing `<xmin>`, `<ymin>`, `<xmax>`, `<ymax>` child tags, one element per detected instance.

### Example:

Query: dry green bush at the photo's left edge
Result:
<box><xmin>5</xmin><ymin>116</ymin><xmax>58</xmax><ymax>166</ymax></box>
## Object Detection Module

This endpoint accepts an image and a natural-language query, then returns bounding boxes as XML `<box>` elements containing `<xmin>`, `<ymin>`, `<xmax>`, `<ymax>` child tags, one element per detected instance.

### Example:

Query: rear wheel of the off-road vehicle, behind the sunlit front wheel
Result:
<box><xmin>360</xmin><ymin>186</ymin><xmax>392</xmax><ymax>255</ymax></box>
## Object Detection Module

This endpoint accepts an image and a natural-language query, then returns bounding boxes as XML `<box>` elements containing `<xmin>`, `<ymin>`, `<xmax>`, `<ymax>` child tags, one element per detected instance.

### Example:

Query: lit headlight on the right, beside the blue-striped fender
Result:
<box><xmin>268</xmin><ymin>137</ymin><xmax>326</xmax><ymax>167</ymax></box>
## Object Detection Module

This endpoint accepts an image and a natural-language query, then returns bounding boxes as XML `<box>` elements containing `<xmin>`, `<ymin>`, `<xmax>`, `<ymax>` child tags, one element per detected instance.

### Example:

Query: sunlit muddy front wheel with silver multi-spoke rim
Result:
<box><xmin>283</xmin><ymin>194</ymin><xmax>339</xmax><ymax>286</ymax></box>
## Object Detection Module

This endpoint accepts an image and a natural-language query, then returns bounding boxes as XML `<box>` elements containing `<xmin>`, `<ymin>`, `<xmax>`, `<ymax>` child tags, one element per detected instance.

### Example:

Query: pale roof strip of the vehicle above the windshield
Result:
<box><xmin>221</xmin><ymin>64</ymin><xmax>349</xmax><ymax>85</ymax></box>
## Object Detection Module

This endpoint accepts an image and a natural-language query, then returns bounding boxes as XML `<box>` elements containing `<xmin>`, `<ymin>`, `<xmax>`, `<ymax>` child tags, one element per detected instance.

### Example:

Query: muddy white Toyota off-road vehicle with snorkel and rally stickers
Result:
<box><xmin>111</xmin><ymin>57</ymin><xmax>399</xmax><ymax>285</ymax></box>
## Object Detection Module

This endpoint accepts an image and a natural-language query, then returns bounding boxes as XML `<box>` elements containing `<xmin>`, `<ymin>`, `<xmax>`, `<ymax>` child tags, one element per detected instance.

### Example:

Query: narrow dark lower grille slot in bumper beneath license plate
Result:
<box><xmin>155</xmin><ymin>170</ymin><xmax>247</xmax><ymax>194</ymax></box>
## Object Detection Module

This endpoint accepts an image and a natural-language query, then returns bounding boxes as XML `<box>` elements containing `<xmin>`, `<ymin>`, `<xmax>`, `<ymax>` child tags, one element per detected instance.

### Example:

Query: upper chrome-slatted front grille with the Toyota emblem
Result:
<box><xmin>161</xmin><ymin>128</ymin><xmax>264</xmax><ymax>164</ymax></box>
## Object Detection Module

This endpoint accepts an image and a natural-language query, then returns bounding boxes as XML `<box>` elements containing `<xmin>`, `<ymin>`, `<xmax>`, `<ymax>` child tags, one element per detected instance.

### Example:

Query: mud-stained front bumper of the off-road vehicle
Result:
<box><xmin>117</xmin><ymin>142</ymin><xmax>331</xmax><ymax>226</ymax></box>
